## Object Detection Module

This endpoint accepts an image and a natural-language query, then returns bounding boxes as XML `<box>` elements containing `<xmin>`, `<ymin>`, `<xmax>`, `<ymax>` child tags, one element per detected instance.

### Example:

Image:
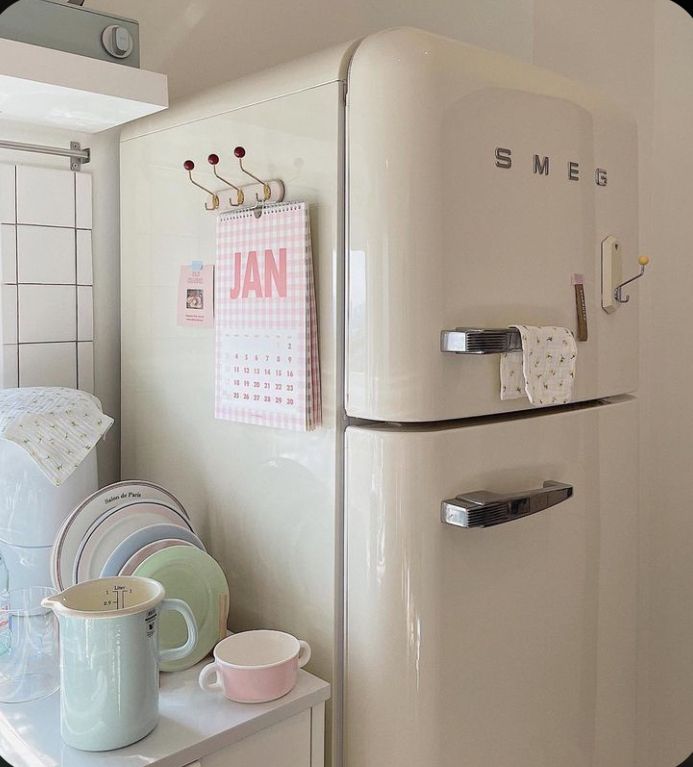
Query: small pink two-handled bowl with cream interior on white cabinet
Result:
<box><xmin>199</xmin><ymin>629</ymin><xmax>310</xmax><ymax>703</ymax></box>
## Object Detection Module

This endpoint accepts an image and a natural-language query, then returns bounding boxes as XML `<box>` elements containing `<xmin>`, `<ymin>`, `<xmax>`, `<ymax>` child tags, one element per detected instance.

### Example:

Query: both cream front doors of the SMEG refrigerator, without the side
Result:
<box><xmin>345</xmin><ymin>30</ymin><xmax>638</xmax><ymax>767</ymax></box>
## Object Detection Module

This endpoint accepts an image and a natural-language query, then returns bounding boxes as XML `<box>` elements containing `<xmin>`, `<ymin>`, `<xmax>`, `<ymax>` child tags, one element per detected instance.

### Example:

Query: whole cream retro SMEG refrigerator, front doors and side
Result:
<box><xmin>121</xmin><ymin>24</ymin><xmax>639</xmax><ymax>767</ymax></box>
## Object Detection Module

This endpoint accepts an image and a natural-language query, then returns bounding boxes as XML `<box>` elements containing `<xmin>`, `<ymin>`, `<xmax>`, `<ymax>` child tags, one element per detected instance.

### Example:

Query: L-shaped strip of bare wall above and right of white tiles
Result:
<box><xmin>0</xmin><ymin>122</ymin><xmax>120</xmax><ymax>484</ymax></box>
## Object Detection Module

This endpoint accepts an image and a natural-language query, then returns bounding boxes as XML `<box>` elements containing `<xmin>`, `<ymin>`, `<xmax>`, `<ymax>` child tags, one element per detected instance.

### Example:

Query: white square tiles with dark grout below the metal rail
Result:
<box><xmin>0</xmin><ymin>165</ymin><xmax>94</xmax><ymax>392</ymax></box>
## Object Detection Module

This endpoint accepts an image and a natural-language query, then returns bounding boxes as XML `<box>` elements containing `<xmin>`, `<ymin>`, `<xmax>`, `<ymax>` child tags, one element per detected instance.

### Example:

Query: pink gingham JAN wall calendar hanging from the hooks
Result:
<box><xmin>214</xmin><ymin>202</ymin><xmax>321</xmax><ymax>431</ymax></box>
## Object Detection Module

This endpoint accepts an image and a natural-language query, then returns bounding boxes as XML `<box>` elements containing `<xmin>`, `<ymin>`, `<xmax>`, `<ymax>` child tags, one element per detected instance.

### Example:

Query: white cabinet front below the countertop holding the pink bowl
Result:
<box><xmin>200</xmin><ymin>710</ymin><xmax>311</xmax><ymax>767</ymax></box>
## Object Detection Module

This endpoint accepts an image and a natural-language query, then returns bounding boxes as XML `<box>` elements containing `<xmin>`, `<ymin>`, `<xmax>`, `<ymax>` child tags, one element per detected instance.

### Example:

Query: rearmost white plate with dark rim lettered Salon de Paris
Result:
<box><xmin>51</xmin><ymin>480</ymin><xmax>187</xmax><ymax>591</ymax></box>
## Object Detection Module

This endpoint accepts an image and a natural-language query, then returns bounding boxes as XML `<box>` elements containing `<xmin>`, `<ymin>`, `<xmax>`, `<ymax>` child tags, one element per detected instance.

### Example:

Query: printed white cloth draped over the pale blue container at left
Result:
<box><xmin>0</xmin><ymin>387</ymin><xmax>113</xmax><ymax>487</ymax></box>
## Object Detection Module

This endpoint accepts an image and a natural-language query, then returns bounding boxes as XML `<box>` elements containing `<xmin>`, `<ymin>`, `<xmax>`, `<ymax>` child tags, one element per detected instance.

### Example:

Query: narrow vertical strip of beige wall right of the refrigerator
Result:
<box><xmin>641</xmin><ymin>0</ymin><xmax>693</xmax><ymax>767</ymax></box>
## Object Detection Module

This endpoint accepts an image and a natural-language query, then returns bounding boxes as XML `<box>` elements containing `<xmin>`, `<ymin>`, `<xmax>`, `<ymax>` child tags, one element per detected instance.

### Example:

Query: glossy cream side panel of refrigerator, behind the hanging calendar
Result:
<box><xmin>121</xmin><ymin>82</ymin><xmax>343</xmax><ymax>720</ymax></box>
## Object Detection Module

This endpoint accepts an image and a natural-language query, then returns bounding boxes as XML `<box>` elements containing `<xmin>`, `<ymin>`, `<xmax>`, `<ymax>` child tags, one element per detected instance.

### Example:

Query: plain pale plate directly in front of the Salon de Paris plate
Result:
<box><xmin>73</xmin><ymin>501</ymin><xmax>193</xmax><ymax>583</ymax></box>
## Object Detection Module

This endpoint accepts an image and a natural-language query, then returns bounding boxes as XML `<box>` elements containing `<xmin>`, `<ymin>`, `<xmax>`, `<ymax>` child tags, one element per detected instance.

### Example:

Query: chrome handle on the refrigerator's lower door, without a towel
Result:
<box><xmin>440</xmin><ymin>480</ymin><xmax>573</xmax><ymax>527</ymax></box>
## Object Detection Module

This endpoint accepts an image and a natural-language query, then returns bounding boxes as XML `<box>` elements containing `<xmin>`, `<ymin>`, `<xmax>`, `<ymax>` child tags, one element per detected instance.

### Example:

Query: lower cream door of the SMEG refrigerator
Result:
<box><xmin>345</xmin><ymin>400</ymin><xmax>637</xmax><ymax>767</ymax></box>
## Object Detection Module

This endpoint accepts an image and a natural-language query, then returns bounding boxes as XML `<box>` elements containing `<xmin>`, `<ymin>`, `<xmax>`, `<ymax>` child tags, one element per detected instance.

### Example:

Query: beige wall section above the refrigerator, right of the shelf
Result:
<box><xmin>87</xmin><ymin>0</ymin><xmax>532</xmax><ymax>100</ymax></box>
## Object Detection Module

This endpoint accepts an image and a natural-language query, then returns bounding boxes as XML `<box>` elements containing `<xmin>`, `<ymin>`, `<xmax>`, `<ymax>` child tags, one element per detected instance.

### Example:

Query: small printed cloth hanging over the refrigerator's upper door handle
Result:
<box><xmin>500</xmin><ymin>325</ymin><xmax>577</xmax><ymax>405</ymax></box>
